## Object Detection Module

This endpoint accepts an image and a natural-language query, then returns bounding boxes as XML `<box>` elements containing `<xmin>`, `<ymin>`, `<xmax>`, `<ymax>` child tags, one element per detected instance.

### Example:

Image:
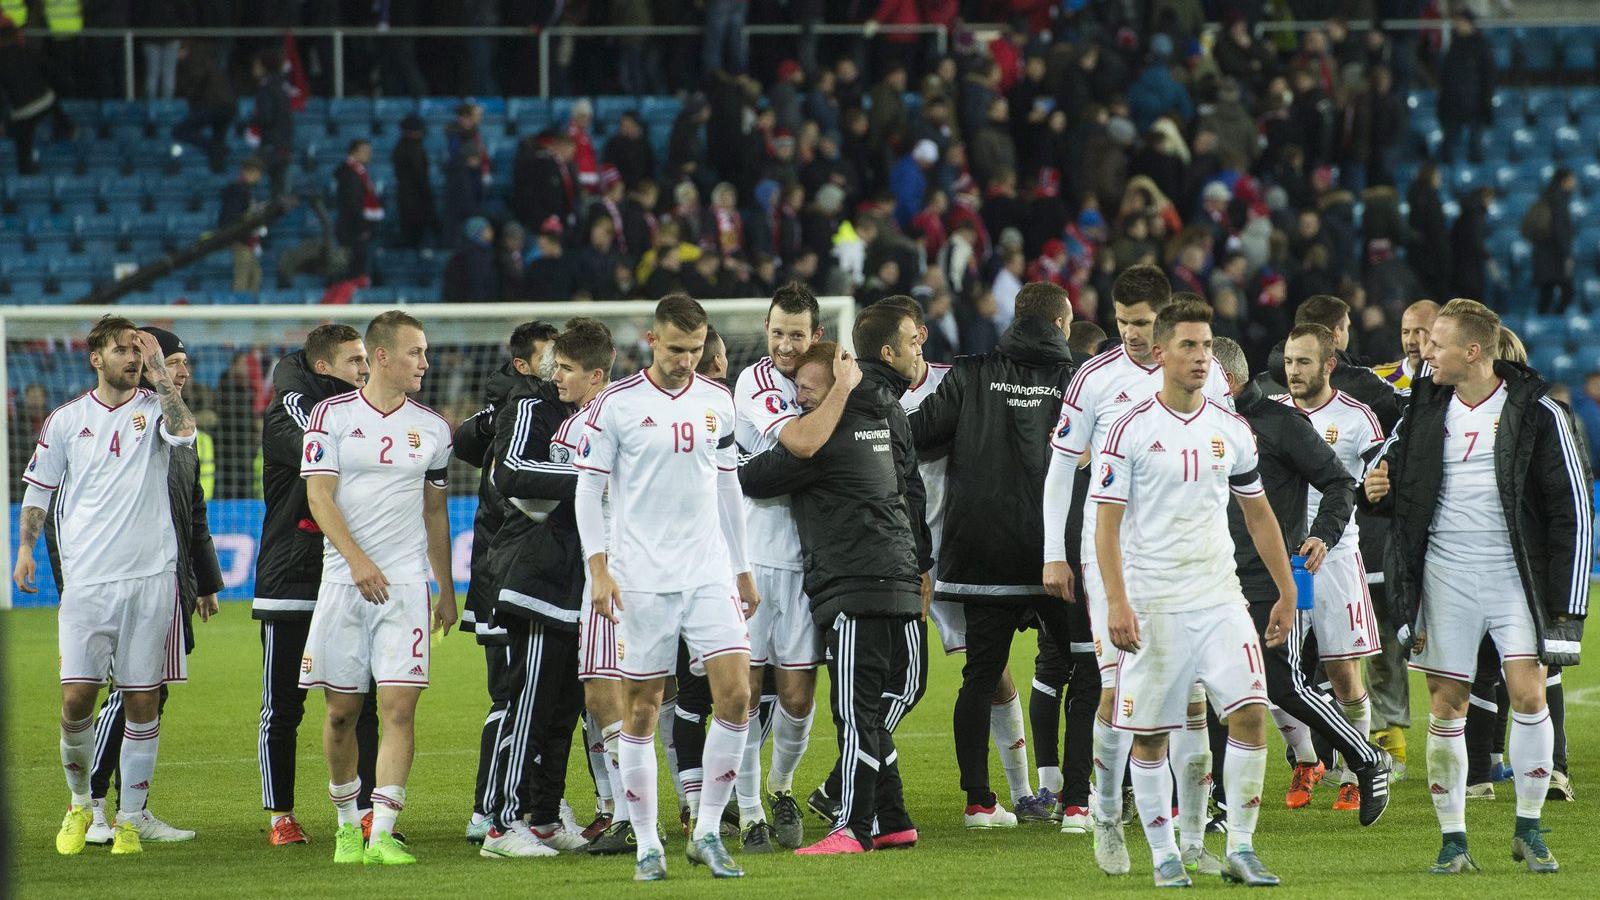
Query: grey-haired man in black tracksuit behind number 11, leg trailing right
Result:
<box><xmin>1211</xmin><ymin>338</ymin><xmax>1389</xmax><ymax>825</ymax></box>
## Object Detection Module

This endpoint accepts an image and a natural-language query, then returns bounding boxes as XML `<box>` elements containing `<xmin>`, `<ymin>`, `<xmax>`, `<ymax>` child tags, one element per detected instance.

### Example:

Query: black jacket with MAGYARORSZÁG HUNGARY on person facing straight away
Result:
<box><xmin>910</xmin><ymin>317</ymin><xmax>1077</xmax><ymax>602</ymax></box>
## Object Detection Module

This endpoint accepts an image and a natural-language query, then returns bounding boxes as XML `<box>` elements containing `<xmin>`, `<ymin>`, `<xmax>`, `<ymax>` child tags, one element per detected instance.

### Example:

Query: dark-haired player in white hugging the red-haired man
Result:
<box><xmin>729</xmin><ymin>282</ymin><xmax>854</xmax><ymax>850</ymax></box>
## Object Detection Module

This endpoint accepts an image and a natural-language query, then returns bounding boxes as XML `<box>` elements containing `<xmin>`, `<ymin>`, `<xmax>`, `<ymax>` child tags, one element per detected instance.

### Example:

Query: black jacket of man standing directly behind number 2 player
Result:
<box><xmin>250</xmin><ymin>351</ymin><xmax>352</xmax><ymax>620</ymax></box>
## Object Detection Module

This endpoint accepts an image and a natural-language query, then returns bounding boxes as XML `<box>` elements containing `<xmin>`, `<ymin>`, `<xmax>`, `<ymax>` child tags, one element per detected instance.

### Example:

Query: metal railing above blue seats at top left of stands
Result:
<box><xmin>27</xmin><ymin>24</ymin><xmax>947</xmax><ymax>101</ymax></box>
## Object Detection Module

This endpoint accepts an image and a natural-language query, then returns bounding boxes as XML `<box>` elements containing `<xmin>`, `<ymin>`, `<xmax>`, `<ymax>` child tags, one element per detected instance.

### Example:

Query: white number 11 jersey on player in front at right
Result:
<box><xmin>1085</xmin><ymin>396</ymin><xmax>1266</xmax><ymax>612</ymax></box>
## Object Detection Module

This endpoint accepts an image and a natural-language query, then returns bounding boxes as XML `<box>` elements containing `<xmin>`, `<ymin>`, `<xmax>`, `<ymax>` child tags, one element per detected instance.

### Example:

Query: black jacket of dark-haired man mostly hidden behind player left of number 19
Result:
<box><xmin>453</xmin><ymin>362</ymin><xmax>554</xmax><ymax>644</ymax></box>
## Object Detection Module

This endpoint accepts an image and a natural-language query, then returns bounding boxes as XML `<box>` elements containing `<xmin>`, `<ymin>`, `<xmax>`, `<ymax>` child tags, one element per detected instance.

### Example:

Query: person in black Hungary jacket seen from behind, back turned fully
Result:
<box><xmin>910</xmin><ymin>282</ymin><xmax>1075</xmax><ymax>828</ymax></box>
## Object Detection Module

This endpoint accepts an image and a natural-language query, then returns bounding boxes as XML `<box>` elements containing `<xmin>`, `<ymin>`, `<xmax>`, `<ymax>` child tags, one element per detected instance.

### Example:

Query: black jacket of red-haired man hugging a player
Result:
<box><xmin>739</xmin><ymin>360</ymin><xmax>931</xmax><ymax>628</ymax></box>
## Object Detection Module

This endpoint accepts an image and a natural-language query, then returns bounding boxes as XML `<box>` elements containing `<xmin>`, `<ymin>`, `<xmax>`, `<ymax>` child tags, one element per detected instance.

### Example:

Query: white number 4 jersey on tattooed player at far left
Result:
<box><xmin>22</xmin><ymin>388</ymin><xmax>194</xmax><ymax>586</ymax></box>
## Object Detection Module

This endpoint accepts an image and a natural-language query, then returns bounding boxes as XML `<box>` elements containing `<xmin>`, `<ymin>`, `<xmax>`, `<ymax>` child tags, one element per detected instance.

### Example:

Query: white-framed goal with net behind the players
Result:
<box><xmin>0</xmin><ymin>296</ymin><xmax>854</xmax><ymax>607</ymax></box>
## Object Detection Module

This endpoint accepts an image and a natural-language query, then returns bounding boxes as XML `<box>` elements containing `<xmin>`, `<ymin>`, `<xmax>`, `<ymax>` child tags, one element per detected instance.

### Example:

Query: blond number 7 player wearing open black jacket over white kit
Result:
<box><xmin>1363</xmin><ymin>299</ymin><xmax>1594</xmax><ymax>874</ymax></box>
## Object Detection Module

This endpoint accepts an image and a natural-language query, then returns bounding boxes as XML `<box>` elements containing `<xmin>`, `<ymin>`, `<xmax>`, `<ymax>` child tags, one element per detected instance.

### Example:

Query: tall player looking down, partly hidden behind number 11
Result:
<box><xmin>1045</xmin><ymin>266</ymin><xmax>1232</xmax><ymax>874</ymax></box>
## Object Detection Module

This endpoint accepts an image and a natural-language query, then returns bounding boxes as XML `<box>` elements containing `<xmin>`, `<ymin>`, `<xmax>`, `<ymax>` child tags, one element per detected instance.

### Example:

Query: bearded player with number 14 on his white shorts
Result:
<box><xmin>1280</xmin><ymin>323</ymin><xmax>1384</xmax><ymax>810</ymax></box>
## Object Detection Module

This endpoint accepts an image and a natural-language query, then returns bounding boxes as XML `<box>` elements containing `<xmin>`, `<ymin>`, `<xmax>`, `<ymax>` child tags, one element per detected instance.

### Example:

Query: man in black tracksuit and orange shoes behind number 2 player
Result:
<box><xmin>250</xmin><ymin>325</ymin><xmax>378</xmax><ymax>847</ymax></box>
